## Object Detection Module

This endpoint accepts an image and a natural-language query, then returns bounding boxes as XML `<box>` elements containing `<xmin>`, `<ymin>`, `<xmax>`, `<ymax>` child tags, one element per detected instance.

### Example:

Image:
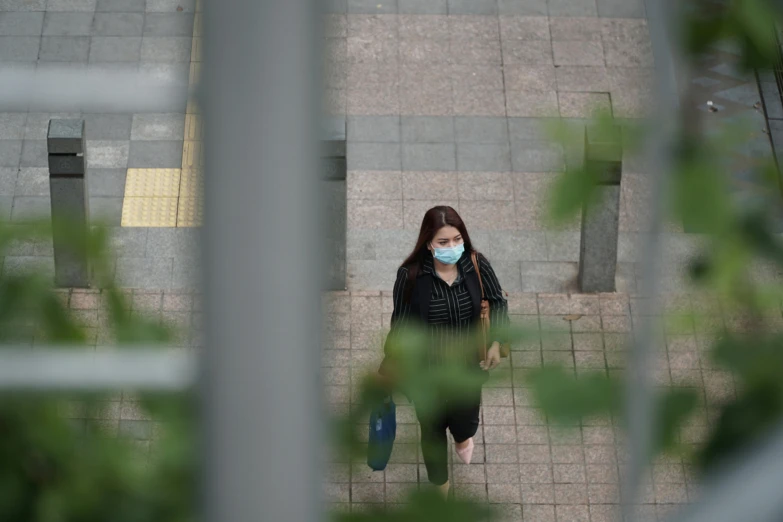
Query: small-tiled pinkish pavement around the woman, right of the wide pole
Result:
<box><xmin>323</xmin><ymin>292</ymin><xmax>743</xmax><ymax>522</ymax></box>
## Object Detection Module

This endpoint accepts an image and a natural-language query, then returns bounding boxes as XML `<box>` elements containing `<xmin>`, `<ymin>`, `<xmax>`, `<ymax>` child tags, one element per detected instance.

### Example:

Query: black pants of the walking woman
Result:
<box><xmin>416</xmin><ymin>388</ymin><xmax>481</xmax><ymax>486</ymax></box>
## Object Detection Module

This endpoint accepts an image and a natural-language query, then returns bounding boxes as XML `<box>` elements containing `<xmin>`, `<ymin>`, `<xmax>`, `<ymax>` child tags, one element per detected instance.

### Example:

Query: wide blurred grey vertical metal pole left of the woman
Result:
<box><xmin>201</xmin><ymin>0</ymin><xmax>327</xmax><ymax>522</ymax></box>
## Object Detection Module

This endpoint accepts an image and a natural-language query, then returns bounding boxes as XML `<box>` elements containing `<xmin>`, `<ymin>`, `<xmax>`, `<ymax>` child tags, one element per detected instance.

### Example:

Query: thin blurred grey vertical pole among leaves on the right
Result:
<box><xmin>620</xmin><ymin>0</ymin><xmax>679</xmax><ymax>521</ymax></box>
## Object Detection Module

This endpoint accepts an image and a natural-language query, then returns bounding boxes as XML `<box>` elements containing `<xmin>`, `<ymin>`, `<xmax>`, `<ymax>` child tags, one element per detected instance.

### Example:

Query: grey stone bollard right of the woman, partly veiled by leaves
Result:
<box><xmin>578</xmin><ymin>126</ymin><xmax>622</xmax><ymax>293</ymax></box>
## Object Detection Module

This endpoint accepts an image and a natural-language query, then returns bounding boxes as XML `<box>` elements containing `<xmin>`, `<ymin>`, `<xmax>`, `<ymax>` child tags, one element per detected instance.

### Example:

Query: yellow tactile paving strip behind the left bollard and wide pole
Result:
<box><xmin>122</xmin><ymin>5</ymin><xmax>204</xmax><ymax>227</ymax></box>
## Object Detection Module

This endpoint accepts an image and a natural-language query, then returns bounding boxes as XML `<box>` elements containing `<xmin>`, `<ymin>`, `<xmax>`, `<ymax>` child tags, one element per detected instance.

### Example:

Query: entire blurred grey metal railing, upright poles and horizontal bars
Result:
<box><xmin>0</xmin><ymin>0</ymin><xmax>783</xmax><ymax>522</ymax></box>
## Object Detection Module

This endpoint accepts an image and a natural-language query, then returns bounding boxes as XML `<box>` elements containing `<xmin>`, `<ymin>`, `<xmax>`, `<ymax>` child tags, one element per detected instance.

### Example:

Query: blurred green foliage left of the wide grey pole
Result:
<box><xmin>0</xmin><ymin>219</ymin><xmax>196</xmax><ymax>522</ymax></box>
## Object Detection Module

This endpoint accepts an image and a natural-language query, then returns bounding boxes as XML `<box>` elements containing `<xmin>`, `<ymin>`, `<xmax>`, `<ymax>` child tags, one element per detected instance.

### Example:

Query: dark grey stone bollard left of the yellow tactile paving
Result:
<box><xmin>47</xmin><ymin>120</ymin><xmax>90</xmax><ymax>288</ymax></box>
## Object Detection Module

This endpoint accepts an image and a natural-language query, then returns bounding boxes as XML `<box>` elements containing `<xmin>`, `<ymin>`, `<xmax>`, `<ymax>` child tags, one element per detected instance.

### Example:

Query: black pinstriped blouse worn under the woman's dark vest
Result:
<box><xmin>391</xmin><ymin>252</ymin><xmax>509</xmax><ymax>366</ymax></box>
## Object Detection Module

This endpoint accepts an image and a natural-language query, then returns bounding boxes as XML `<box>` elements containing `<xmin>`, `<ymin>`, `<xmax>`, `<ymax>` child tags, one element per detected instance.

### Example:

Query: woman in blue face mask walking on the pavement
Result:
<box><xmin>380</xmin><ymin>206</ymin><xmax>508</xmax><ymax>495</ymax></box>
